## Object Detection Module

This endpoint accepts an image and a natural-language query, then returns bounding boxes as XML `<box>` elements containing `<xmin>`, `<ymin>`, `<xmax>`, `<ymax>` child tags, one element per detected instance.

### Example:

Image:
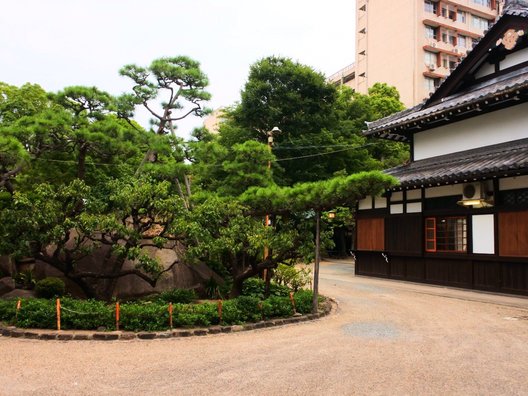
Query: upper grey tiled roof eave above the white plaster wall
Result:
<box><xmin>365</xmin><ymin>67</ymin><xmax>528</xmax><ymax>135</ymax></box>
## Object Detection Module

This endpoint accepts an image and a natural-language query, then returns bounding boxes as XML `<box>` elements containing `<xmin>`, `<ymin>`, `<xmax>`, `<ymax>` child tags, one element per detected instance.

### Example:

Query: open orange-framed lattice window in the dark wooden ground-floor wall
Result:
<box><xmin>425</xmin><ymin>217</ymin><xmax>467</xmax><ymax>253</ymax></box>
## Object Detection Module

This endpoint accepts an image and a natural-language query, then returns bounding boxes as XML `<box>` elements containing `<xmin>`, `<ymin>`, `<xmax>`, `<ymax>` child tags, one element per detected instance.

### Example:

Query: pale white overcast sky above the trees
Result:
<box><xmin>0</xmin><ymin>0</ymin><xmax>355</xmax><ymax>136</ymax></box>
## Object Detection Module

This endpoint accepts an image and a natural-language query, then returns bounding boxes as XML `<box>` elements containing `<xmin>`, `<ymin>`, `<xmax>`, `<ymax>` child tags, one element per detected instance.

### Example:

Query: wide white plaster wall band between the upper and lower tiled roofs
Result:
<box><xmin>414</xmin><ymin>103</ymin><xmax>528</xmax><ymax>161</ymax></box>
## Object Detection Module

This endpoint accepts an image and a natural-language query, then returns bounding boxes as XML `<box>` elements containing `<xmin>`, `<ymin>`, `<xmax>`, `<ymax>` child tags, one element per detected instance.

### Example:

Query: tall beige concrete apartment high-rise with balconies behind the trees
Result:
<box><xmin>329</xmin><ymin>0</ymin><xmax>502</xmax><ymax>107</ymax></box>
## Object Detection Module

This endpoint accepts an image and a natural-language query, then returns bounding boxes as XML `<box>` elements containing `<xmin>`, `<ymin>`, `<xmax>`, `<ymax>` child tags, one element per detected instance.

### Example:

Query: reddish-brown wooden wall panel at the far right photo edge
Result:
<box><xmin>499</xmin><ymin>211</ymin><xmax>528</xmax><ymax>257</ymax></box>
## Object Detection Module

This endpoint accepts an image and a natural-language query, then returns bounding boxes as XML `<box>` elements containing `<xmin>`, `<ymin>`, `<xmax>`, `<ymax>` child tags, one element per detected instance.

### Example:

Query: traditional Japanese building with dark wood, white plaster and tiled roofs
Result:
<box><xmin>355</xmin><ymin>0</ymin><xmax>528</xmax><ymax>294</ymax></box>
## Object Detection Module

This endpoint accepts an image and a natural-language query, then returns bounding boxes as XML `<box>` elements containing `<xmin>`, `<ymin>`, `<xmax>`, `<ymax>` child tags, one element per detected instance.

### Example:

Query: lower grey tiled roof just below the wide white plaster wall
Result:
<box><xmin>385</xmin><ymin>139</ymin><xmax>528</xmax><ymax>187</ymax></box>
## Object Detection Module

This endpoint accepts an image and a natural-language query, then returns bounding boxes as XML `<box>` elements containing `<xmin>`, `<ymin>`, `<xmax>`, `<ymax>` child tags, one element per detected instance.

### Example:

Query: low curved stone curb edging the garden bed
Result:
<box><xmin>0</xmin><ymin>298</ymin><xmax>338</xmax><ymax>341</ymax></box>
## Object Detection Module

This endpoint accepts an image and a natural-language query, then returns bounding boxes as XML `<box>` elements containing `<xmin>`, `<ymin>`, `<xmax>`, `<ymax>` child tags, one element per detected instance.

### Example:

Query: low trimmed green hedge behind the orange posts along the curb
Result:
<box><xmin>0</xmin><ymin>290</ymin><xmax>318</xmax><ymax>331</ymax></box>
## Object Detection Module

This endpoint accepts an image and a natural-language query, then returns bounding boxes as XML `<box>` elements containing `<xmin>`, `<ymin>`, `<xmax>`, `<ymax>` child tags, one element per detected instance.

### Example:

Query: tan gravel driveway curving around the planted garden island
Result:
<box><xmin>0</xmin><ymin>262</ymin><xmax>528</xmax><ymax>395</ymax></box>
